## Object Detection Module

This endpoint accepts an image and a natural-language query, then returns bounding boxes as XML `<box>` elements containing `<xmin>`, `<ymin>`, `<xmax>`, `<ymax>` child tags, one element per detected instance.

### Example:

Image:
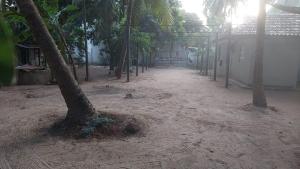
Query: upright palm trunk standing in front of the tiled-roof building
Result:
<box><xmin>253</xmin><ymin>0</ymin><xmax>267</xmax><ymax>107</ymax></box>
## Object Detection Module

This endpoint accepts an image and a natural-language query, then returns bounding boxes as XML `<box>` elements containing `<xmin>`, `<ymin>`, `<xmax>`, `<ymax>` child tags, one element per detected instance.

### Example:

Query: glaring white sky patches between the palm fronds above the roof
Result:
<box><xmin>181</xmin><ymin>0</ymin><xmax>258</xmax><ymax>24</ymax></box>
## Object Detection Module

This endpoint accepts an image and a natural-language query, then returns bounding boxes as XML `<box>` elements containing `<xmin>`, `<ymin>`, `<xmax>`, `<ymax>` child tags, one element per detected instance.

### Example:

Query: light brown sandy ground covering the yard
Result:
<box><xmin>0</xmin><ymin>68</ymin><xmax>300</xmax><ymax>169</ymax></box>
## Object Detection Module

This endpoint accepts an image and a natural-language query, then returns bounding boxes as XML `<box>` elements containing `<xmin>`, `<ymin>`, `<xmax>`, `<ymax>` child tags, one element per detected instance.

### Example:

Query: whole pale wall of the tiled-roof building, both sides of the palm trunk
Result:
<box><xmin>218</xmin><ymin>36</ymin><xmax>300</xmax><ymax>88</ymax></box>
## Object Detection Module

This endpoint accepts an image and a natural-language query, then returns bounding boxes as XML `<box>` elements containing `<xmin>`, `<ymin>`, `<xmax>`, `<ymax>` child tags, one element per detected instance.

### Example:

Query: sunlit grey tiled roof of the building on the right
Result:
<box><xmin>232</xmin><ymin>14</ymin><xmax>300</xmax><ymax>36</ymax></box>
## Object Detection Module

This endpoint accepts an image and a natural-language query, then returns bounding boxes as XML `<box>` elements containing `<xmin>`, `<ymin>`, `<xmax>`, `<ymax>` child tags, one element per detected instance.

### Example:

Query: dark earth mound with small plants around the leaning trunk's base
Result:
<box><xmin>49</xmin><ymin>112</ymin><xmax>145</xmax><ymax>139</ymax></box>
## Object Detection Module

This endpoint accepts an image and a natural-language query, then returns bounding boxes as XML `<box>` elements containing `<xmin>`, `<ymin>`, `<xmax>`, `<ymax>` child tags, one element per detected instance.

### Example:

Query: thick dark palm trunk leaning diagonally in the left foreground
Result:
<box><xmin>16</xmin><ymin>0</ymin><xmax>95</xmax><ymax>125</ymax></box>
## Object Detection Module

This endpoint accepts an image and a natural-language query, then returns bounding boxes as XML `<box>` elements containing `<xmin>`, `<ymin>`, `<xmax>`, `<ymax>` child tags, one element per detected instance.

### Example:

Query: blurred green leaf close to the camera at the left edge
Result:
<box><xmin>0</xmin><ymin>15</ymin><xmax>15</xmax><ymax>85</ymax></box>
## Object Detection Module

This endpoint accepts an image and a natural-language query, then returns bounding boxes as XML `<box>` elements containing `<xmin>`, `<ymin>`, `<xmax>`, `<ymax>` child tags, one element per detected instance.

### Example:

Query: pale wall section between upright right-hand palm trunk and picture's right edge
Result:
<box><xmin>264</xmin><ymin>36</ymin><xmax>300</xmax><ymax>88</ymax></box>
